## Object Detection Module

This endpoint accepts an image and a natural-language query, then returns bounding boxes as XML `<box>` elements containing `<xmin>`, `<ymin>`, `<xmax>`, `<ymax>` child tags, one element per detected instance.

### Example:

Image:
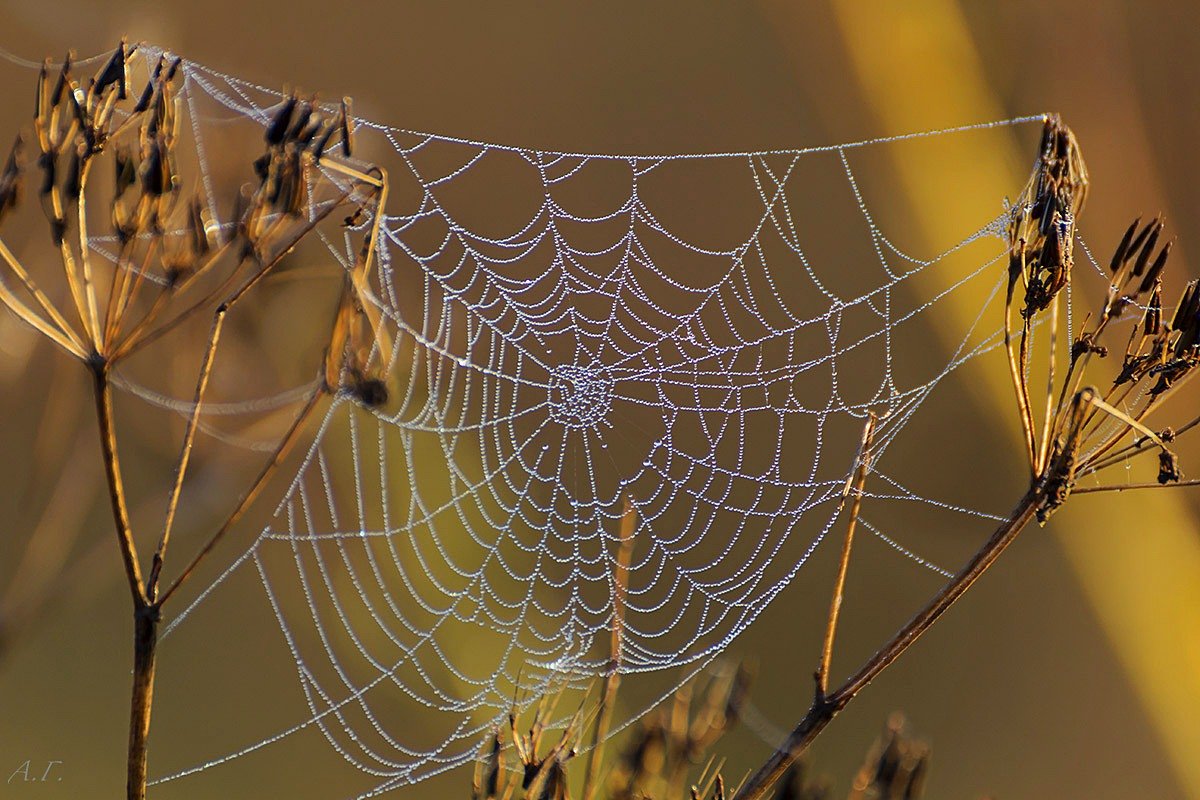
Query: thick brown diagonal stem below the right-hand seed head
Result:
<box><xmin>734</xmin><ymin>484</ymin><xmax>1041</xmax><ymax>800</ymax></box>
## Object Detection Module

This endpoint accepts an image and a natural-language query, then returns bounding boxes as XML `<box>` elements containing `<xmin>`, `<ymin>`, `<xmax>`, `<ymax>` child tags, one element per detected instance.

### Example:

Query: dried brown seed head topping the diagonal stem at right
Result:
<box><xmin>1004</xmin><ymin>118</ymin><xmax>1200</xmax><ymax>522</ymax></box>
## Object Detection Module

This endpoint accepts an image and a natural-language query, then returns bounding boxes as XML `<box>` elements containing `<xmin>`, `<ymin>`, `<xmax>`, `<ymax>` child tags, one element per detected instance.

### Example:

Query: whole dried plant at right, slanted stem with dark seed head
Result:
<box><xmin>734</xmin><ymin>116</ymin><xmax>1200</xmax><ymax>800</ymax></box>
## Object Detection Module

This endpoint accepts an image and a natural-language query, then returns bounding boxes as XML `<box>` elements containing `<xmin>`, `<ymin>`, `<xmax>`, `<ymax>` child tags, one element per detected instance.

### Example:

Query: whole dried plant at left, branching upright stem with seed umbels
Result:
<box><xmin>0</xmin><ymin>41</ymin><xmax>390</xmax><ymax>799</ymax></box>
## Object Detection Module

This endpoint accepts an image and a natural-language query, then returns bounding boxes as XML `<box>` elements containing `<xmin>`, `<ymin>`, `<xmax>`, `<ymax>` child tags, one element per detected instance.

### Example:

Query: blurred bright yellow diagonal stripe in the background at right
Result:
<box><xmin>816</xmin><ymin>0</ymin><xmax>1200</xmax><ymax>796</ymax></box>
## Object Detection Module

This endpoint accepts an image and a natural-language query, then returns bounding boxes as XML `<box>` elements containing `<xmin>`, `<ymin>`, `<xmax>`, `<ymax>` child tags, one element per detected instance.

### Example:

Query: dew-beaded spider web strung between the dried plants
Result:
<box><xmin>0</xmin><ymin>48</ymin><xmax>1040</xmax><ymax>796</ymax></box>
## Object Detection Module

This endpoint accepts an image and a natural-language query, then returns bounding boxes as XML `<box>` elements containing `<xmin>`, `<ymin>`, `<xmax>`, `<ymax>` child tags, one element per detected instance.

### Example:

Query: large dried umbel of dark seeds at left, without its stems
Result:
<box><xmin>0</xmin><ymin>42</ymin><xmax>386</xmax><ymax>393</ymax></box>
